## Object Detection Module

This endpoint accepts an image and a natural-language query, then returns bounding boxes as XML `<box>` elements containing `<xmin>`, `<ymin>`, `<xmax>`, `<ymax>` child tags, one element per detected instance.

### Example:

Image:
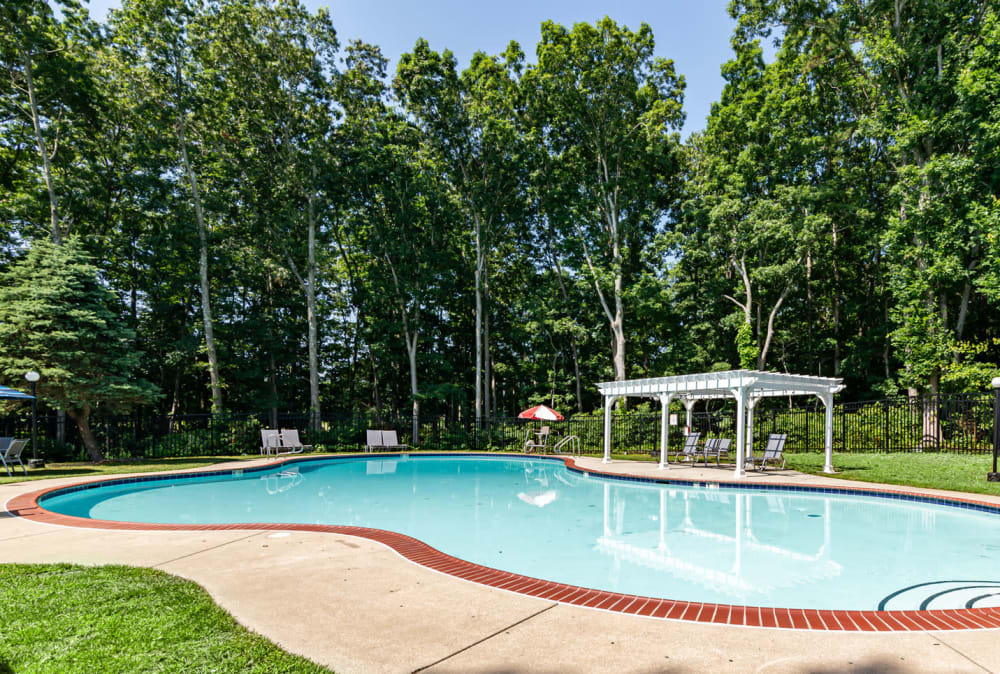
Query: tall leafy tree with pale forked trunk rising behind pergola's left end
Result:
<box><xmin>524</xmin><ymin>18</ymin><xmax>684</xmax><ymax>381</ymax></box>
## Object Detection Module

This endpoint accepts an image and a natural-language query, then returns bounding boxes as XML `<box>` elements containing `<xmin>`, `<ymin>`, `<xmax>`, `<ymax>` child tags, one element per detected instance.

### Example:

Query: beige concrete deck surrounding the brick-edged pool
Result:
<box><xmin>0</xmin><ymin>457</ymin><xmax>1000</xmax><ymax>673</ymax></box>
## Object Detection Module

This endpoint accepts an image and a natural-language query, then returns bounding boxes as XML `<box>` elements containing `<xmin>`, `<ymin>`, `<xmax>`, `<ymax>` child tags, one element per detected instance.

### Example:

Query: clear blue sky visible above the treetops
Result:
<box><xmin>80</xmin><ymin>0</ymin><xmax>734</xmax><ymax>137</ymax></box>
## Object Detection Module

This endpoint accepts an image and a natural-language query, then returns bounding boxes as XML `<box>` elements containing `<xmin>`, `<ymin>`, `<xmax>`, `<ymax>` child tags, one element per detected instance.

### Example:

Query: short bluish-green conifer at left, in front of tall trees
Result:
<box><xmin>0</xmin><ymin>237</ymin><xmax>159</xmax><ymax>462</ymax></box>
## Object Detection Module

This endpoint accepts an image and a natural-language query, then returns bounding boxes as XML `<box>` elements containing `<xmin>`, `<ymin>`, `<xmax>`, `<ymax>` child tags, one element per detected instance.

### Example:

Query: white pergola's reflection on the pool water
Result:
<box><xmin>596</xmin><ymin>483</ymin><xmax>842</xmax><ymax>597</ymax></box>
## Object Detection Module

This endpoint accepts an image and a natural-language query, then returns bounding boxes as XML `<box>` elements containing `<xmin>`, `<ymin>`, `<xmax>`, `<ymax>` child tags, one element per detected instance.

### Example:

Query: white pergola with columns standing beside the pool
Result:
<box><xmin>597</xmin><ymin>370</ymin><xmax>844</xmax><ymax>478</ymax></box>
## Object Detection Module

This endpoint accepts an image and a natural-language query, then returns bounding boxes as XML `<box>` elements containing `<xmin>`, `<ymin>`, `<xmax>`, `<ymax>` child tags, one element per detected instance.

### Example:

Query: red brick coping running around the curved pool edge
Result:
<box><xmin>6</xmin><ymin>452</ymin><xmax>1000</xmax><ymax>632</ymax></box>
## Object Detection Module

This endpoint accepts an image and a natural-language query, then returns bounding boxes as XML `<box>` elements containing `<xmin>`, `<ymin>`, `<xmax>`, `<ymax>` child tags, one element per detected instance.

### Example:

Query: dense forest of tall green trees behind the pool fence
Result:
<box><xmin>0</xmin><ymin>0</ymin><xmax>1000</xmax><ymax>452</ymax></box>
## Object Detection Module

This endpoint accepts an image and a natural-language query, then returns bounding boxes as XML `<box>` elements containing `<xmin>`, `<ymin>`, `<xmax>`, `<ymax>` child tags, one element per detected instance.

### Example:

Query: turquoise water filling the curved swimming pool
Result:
<box><xmin>41</xmin><ymin>456</ymin><xmax>1000</xmax><ymax>609</ymax></box>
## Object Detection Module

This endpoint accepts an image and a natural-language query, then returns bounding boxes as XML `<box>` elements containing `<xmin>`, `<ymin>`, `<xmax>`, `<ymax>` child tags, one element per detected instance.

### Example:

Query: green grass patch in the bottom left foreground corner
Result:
<box><xmin>0</xmin><ymin>564</ymin><xmax>330</xmax><ymax>674</ymax></box>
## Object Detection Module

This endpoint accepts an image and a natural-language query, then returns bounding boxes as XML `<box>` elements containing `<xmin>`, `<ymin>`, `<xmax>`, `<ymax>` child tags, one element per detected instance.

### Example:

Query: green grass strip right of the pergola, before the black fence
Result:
<box><xmin>786</xmin><ymin>452</ymin><xmax>1000</xmax><ymax>496</ymax></box>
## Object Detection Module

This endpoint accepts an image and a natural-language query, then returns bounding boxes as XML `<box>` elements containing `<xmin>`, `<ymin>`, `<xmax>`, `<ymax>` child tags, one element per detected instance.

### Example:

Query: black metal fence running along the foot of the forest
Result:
<box><xmin>0</xmin><ymin>394</ymin><xmax>994</xmax><ymax>460</ymax></box>
